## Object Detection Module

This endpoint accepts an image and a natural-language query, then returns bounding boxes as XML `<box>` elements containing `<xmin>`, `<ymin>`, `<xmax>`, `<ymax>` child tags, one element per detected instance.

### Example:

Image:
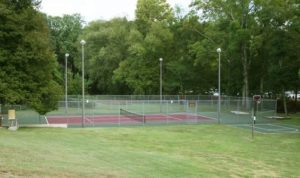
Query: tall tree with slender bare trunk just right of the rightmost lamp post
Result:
<box><xmin>195</xmin><ymin>0</ymin><xmax>255</xmax><ymax>104</ymax></box>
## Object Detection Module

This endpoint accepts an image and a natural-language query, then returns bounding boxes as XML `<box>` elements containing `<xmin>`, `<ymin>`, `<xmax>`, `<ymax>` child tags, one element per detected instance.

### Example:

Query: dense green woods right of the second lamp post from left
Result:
<box><xmin>67</xmin><ymin>0</ymin><xmax>300</xmax><ymax>97</ymax></box>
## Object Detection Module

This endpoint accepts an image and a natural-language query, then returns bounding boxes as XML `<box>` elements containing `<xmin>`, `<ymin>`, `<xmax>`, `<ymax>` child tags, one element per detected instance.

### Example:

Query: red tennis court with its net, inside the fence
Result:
<box><xmin>47</xmin><ymin>109</ymin><xmax>216</xmax><ymax>127</ymax></box>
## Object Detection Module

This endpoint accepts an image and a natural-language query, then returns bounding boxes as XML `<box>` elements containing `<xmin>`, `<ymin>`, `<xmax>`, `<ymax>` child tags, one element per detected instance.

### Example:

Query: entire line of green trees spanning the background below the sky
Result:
<box><xmin>0</xmin><ymin>0</ymin><xmax>300</xmax><ymax>114</ymax></box>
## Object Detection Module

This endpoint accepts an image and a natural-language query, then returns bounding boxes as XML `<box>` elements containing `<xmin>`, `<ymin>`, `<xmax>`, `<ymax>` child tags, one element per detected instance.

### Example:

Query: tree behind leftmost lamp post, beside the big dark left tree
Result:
<box><xmin>47</xmin><ymin>14</ymin><xmax>83</xmax><ymax>94</ymax></box>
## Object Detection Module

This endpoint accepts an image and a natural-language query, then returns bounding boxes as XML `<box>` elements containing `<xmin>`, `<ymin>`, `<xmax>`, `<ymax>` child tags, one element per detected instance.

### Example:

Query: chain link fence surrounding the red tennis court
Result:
<box><xmin>1</xmin><ymin>95</ymin><xmax>277</xmax><ymax>127</ymax></box>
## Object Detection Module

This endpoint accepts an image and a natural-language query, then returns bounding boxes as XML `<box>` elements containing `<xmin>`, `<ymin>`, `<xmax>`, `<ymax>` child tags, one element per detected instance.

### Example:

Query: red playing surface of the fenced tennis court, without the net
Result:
<box><xmin>47</xmin><ymin>114</ymin><xmax>215</xmax><ymax>125</ymax></box>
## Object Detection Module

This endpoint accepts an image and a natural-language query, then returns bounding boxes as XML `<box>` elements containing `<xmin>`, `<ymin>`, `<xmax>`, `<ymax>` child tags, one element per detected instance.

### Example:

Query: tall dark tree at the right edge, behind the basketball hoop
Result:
<box><xmin>256</xmin><ymin>0</ymin><xmax>300</xmax><ymax>114</ymax></box>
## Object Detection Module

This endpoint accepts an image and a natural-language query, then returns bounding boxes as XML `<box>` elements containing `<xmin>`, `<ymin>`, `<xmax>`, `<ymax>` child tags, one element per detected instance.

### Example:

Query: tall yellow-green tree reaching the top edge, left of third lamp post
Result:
<box><xmin>114</xmin><ymin>0</ymin><xmax>174</xmax><ymax>94</ymax></box>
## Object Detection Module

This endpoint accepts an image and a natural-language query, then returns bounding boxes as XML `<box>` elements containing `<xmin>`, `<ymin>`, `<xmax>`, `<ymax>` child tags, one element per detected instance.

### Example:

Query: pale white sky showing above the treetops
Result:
<box><xmin>40</xmin><ymin>0</ymin><xmax>192</xmax><ymax>22</ymax></box>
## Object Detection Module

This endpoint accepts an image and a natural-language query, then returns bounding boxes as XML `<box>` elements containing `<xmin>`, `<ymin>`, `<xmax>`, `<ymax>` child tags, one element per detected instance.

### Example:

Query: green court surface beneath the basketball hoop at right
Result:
<box><xmin>234</xmin><ymin>123</ymin><xmax>300</xmax><ymax>133</ymax></box>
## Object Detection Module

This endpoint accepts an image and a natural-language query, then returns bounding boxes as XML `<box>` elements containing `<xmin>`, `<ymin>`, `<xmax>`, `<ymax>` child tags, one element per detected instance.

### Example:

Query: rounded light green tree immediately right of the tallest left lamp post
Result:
<box><xmin>81</xmin><ymin>18</ymin><xmax>131</xmax><ymax>94</ymax></box>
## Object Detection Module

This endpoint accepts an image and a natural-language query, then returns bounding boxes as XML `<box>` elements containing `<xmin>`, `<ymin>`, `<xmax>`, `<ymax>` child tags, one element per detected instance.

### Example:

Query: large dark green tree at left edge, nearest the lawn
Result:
<box><xmin>0</xmin><ymin>0</ymin><xmax>61</xmax><ymax>113</ymax></box>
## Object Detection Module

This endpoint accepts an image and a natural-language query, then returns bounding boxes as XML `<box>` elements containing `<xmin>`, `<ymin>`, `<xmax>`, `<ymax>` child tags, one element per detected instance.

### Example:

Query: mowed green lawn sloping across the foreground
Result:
<box><xmin>0</xmin><ymin>118</ymin><xmax>300</xmax><ymax>178</ymax></box>
